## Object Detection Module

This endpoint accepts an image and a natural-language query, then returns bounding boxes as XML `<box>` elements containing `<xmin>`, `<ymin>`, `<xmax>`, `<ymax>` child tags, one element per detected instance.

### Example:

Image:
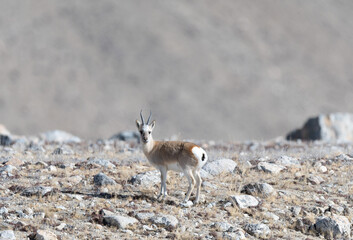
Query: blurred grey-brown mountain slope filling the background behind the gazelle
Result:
<box><xmin>0</xmin><ymin>0</ymin><xmax>353</xmax><ymax>140</ymax></box>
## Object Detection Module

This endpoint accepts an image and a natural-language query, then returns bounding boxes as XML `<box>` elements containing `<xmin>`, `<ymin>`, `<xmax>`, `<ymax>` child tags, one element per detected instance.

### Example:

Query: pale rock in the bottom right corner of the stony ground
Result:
<box><xmin>314</xmin><ymin>215</ymin><xmax>351</xmax><ymax>239</ymax></box>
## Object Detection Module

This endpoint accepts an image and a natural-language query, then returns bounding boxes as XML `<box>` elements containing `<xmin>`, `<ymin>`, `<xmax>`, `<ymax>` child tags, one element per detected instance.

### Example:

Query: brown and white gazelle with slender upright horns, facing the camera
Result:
<box><xmin>136</xmin><ymin>110</ymin><xmax>208</xmax><ymax>204</ymax></box>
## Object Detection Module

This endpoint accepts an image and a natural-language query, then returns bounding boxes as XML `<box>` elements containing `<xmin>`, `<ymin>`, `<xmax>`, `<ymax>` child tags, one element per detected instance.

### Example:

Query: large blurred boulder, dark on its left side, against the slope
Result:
<box><xmin>286</xmin><ymin>113</ymin><xmax>353</xmax><ymax>142</ymax></box>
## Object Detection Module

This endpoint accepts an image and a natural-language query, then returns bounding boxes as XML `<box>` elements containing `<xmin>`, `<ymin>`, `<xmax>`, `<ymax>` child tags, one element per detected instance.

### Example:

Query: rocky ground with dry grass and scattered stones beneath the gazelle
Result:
<box><xmin>0</xmin><ymin>131</ymin><xmax>353</xmax><ymax>239</ymax></box>
